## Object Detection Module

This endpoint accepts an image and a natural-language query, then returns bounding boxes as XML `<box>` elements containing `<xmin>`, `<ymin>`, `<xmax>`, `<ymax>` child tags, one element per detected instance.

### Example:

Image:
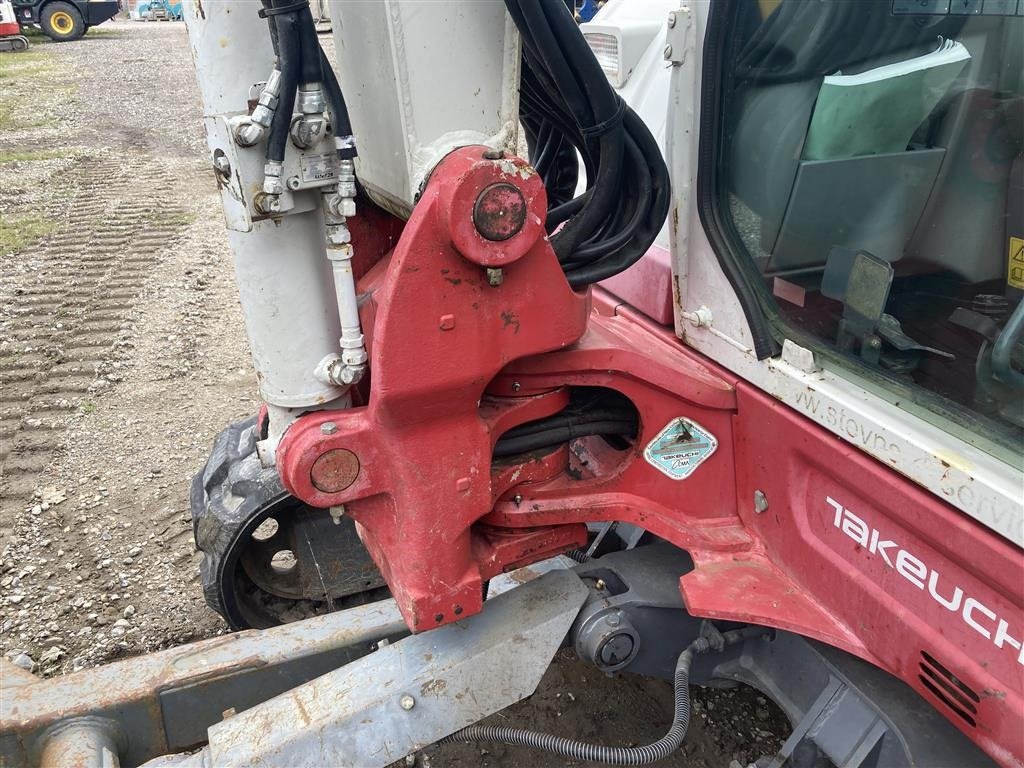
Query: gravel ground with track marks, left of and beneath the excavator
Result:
<box><xmin>0</xmin><ymin>22</ymin><xmax>787</xmax><ymax>768</ymax></box>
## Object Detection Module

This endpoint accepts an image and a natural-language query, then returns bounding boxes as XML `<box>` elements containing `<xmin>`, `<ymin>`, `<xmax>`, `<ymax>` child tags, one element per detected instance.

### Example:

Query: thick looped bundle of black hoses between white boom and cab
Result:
<box><xmin>505</xmin><ymin>0</ymin><xmax>670</xmax><ymax>288</ymax></box>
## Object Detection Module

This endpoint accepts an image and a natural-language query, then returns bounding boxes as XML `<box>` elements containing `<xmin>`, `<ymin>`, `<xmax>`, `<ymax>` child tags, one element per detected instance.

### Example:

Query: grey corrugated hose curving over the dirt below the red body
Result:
<box><xmin>441</xmin><ymin>627</ymin><xmax>765</xmax><ymax>765</ymax></box>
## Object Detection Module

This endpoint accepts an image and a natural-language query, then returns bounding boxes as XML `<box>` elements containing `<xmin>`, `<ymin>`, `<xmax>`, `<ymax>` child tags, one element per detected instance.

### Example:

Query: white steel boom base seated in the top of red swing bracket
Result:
<box><xmin>330</xmin><ymin>0</ymin><xmax>519</xmax><ymax>215</ymax></box>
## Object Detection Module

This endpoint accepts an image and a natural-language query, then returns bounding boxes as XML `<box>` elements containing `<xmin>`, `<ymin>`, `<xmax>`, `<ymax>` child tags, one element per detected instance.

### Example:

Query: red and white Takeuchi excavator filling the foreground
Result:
<box><xmin>0</xmin><ymin>0</ymin><xmax>1024</xmax><ymax>768</ymax></box>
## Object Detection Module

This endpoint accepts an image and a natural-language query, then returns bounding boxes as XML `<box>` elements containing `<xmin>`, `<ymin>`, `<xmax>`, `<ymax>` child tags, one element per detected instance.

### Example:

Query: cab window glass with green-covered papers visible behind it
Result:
<box><xmin>719</xmin><ymin>0</ymin><xmax>1024</xmax><ymax>447</ymax></box>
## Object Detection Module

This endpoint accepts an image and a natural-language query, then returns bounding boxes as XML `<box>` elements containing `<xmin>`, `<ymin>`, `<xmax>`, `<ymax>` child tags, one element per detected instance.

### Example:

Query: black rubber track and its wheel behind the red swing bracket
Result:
<box><xmin>191</xmin><ymin>419</ymin><xmax>388</xmax><ymax>630</ymax></box>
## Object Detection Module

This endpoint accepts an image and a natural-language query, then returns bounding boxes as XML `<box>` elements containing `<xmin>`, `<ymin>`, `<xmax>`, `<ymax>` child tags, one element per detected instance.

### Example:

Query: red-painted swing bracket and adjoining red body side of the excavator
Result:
<box><xmin>278</xmin><ymin>147</ymin><xmax>1024</xmax><ymax>765</ymax></box>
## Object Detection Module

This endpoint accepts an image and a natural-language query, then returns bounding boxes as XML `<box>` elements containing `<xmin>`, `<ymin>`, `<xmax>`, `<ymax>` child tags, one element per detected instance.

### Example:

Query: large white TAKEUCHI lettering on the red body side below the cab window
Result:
<box><xmin>825</xmin><ymin>497</ymin><xmax>1024</xmax><ymax>665</ymax></box>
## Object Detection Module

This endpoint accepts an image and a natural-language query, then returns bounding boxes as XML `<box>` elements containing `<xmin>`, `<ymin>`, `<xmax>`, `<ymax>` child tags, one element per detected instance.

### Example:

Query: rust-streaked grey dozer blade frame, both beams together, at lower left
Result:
<box><xmin>0</xmin><ymin>570</ymin><xmax>588</xmax><ymax>768</ymax></box>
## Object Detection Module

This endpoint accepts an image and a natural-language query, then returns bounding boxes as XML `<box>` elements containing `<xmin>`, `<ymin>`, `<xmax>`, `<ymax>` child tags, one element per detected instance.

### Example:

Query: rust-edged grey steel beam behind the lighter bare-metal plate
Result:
<box><xmin>0</xmin><ymin>600</ymin><xmax>406</xmax><ymax>768</ymax></box>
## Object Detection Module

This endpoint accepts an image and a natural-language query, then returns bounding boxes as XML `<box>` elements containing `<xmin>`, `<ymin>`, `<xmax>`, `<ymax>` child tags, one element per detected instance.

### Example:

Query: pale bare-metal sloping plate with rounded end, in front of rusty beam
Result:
<box><xmin>173</xmin><ymin>570</ymin><xmax>589</xmax><ymax>768</ymax></box>
